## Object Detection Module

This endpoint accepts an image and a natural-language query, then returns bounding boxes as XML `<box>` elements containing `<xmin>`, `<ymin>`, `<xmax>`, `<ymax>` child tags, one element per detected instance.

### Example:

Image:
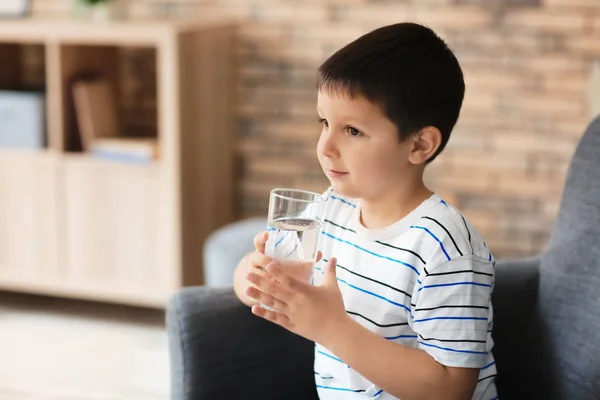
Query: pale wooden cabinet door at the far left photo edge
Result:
<box><xmin>0</xmin><ymin>151</ymin><xmax>59</xmax><ymax>281</ymax></box>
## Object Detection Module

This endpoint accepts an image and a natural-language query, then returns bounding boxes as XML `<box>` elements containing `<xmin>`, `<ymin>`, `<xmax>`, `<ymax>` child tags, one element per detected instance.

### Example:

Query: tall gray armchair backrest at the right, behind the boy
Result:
<box><xmin>537</xmin><ymin>117</ymin><xmax>600</xmax><ymax>400</ymax></box>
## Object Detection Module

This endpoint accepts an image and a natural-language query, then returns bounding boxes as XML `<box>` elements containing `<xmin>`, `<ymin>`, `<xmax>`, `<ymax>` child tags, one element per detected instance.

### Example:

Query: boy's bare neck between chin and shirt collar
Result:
<box><xmin>360</xmin><ymin>179</ymin><xmax>433</xmax><ymax>229</ymax></box>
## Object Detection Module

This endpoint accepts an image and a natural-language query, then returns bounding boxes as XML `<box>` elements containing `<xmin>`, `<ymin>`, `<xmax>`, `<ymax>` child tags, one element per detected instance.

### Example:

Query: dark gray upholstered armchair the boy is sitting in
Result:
<box><xmin>167</xmin><ymin>118</ymin><xmax>600</xmax><ymax>400</ymax></box>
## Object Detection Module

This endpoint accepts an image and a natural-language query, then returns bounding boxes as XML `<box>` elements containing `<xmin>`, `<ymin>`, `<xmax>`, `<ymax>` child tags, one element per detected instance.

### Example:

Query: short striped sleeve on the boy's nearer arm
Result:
<box><xmin>411</xmin><ymin>255</ymin><xmax>494</xmax><ymax>368</ymax></box>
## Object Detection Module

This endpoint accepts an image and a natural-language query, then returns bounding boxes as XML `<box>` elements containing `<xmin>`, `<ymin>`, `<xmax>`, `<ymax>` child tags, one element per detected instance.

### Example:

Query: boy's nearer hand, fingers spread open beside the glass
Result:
<box><xmin>246</xmin><ymin>258</ymin><xmax>349</xmax><ymax>343</ymax></box>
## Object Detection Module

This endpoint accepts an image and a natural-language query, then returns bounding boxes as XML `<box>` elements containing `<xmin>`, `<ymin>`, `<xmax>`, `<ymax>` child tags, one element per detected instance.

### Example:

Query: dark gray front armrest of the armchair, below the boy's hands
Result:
<box><xmin>167</xmin><ymin>287</ymin><xmax>317</xmax><ymax>400</ymax></box>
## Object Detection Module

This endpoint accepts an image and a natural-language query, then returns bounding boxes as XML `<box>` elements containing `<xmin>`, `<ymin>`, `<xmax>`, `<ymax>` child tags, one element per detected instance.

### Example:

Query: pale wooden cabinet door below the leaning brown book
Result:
<box><xmin>64</xmin><ymin>157</ymin><xmax>168</xmax><ymax>293</ymax></box>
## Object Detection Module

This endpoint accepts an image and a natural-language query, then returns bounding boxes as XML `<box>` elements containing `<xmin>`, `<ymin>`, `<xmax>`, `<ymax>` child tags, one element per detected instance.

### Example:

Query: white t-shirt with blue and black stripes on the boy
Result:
<box><xmin>314</xmin><ymin>191</ymin><xmax>497</xmax><ymax>400</ymax></box>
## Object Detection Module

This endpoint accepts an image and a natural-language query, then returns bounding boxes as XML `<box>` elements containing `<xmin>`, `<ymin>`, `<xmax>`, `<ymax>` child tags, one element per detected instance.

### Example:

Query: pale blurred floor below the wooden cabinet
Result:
<box><xmin>0</xmin><ymin>292</ymin><xmax>169</xmax><ymax>400</ymax></box>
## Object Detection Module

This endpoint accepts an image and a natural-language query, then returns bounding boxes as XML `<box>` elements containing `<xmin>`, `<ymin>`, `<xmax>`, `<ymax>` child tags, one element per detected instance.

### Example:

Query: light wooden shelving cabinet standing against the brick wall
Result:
<box><xmin>0</xmin><ymin>16</ymin><xmax>235</xmax><ymax>307</ymax></box>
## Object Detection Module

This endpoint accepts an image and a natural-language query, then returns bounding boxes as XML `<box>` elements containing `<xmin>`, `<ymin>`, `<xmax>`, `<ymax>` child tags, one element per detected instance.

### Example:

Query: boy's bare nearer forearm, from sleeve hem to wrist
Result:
<box><xmin>323</xmin><ymin>318</ymin><xmax>479</xmax><ymax>400</ymax></box>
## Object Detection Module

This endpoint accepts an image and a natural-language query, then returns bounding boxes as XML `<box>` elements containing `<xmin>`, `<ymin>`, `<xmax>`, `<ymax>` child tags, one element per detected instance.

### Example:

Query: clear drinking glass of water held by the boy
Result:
<box><xmin>265</xmin><ymin>189</ymin><xmax>326</xmax><ymax>282</ymax></box>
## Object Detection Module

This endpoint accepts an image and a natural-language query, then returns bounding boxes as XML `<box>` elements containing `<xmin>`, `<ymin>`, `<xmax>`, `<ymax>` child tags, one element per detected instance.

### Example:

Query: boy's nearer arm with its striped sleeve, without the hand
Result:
<box><xmin>323</xmin><ymin>256</ymin><xmax>494</xmax><ymax>400</ymax></box>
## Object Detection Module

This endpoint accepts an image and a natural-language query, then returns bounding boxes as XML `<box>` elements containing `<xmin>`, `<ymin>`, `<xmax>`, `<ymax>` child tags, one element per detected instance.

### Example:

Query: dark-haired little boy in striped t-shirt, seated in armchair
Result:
<box><xmin>234</xmin><ymin>23</ymin><xmax>498</xmax><ymax>400</ymax></box>
